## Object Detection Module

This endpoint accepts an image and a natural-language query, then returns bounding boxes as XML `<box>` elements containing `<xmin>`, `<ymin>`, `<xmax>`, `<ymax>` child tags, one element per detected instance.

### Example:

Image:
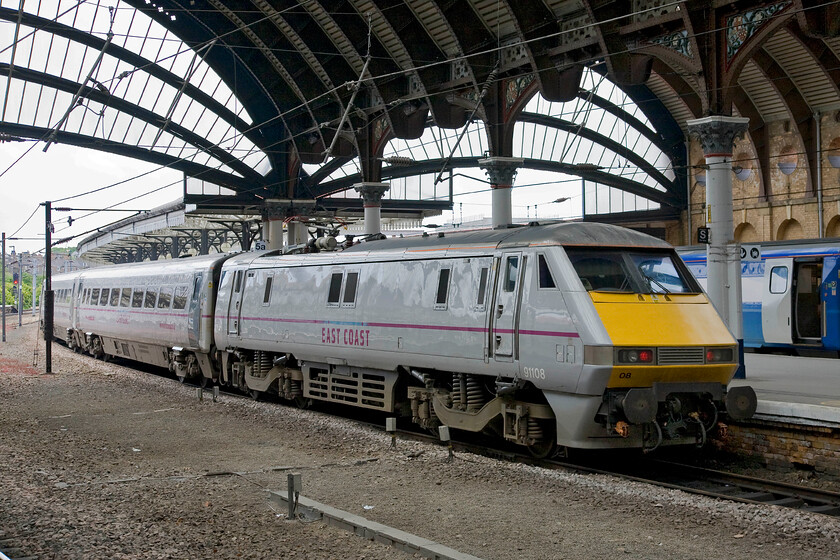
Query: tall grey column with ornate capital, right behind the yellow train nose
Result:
<box><xmin>686</xmin><ymin>116</ymin><xmax>749</xmax><ymax>377</ymax></box>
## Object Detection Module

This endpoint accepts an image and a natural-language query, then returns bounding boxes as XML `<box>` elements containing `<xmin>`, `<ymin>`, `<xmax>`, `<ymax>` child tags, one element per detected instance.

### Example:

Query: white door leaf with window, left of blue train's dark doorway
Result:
<box><xmin>761</xmin><ymin>259</ymin><xmax>793</xmax><ymax>344</ymax></box>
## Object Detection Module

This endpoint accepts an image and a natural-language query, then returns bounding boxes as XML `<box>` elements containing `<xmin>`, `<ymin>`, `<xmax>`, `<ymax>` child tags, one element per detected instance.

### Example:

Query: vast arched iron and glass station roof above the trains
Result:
<box><xmin>0</xmin><ymin>0</ymin><xmax>840</xmax><ymax>260</ymax></box>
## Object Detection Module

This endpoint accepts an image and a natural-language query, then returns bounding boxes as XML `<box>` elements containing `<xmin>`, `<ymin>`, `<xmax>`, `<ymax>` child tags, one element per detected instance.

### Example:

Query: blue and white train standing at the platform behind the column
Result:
<box><xmin>678</xmin><ymin>239</ymin><xmax>840</xmax><ymax>357</ymax></box>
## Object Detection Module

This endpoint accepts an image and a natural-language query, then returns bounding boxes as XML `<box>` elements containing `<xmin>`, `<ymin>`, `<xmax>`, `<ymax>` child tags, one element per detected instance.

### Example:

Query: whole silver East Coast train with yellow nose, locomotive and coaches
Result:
<box><xmin>42</xmin><ymin>223</ymin><xmax>755</xmax><ymax>454</ymax></box>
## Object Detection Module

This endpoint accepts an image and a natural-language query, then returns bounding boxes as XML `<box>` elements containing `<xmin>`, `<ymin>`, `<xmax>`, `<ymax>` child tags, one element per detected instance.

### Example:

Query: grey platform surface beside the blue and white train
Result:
<box><xmin>732</xmin><ymin>353</ymin><xmax>840</xmax><ymax>426</ymax></box>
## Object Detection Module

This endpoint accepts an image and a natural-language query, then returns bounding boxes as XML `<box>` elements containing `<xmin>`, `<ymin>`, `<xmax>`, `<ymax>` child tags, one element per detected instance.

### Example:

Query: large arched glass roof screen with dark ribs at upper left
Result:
<box><xmin>0</xmin><ymin>0</ymin><xmax>267</xmax><ymax>178</ymax></box>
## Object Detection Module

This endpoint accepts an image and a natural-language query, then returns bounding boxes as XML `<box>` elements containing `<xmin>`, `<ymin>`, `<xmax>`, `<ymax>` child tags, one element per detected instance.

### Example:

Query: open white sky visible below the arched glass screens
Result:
<box><xmin>0</xmin><ymin>142</ymin><xmax>581</xmax><ymax>253</ymax></box>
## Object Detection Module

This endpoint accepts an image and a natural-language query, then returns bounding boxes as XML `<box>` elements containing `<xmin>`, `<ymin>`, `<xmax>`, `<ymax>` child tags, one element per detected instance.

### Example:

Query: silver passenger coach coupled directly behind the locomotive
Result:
<box><xmin>53</xmin><ymin>255</ymin><xmax>229</xmax><ymax>380</ymax></box>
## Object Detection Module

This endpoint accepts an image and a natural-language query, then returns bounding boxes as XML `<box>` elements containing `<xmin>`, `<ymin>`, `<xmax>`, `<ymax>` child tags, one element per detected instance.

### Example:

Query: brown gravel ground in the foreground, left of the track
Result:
<box><xmin>0</xmin><ymin>324</ymin><xmax>840</xmax><ymax>560</ymax></box>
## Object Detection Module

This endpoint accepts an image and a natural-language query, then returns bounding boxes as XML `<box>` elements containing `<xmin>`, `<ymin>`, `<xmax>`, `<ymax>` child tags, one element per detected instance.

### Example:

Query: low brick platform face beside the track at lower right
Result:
<box><xmin>712</xmin><ymin>419</ymin><xmax>840</xmax><ymax>476</ymax></box>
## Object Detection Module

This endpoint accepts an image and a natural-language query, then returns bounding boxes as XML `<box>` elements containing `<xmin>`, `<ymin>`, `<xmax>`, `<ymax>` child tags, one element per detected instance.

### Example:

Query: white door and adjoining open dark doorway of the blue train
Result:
<box><xmin>761</xmin><ymin>258</ymin><xmax>825</xmax><ymax>346</ymax></box>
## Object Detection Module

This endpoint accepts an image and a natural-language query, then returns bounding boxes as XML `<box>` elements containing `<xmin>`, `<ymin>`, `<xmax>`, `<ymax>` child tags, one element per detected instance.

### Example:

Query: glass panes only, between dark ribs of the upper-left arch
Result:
<box><xmin>0</xmin><ymin>0</ymin><xmax>267</xmax><ymax>179</ymax></box>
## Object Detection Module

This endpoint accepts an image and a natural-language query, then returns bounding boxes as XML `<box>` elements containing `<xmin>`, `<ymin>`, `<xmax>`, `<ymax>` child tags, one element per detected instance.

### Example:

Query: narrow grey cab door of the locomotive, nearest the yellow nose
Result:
<box><xmin>492</xmin><ymin>253</ymin><xmax>525</xmax><ymax>362</ymax></box>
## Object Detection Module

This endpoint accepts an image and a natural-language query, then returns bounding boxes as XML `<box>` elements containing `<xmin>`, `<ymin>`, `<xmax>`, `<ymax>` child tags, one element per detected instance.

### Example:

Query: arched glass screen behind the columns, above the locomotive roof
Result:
<box><xmin>314</xmin><ymin>69</ymin><xmax>676</xmax><ymax>217</ymax></box>
